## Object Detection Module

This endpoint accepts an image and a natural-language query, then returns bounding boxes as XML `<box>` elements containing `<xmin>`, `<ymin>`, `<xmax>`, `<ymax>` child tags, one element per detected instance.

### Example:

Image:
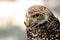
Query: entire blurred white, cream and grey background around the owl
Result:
<box><xmin>0</xmin><ymin>0</ymin><xmax>60</xmax><ymax>40</ymax></box>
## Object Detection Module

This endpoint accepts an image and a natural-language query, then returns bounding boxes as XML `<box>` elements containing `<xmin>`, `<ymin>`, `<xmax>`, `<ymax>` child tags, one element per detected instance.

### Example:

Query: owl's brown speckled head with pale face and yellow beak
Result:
<box><xmin>25</xmin><ymin>5</ymin><xmax>54</xmax><ymax>25</ymax></box>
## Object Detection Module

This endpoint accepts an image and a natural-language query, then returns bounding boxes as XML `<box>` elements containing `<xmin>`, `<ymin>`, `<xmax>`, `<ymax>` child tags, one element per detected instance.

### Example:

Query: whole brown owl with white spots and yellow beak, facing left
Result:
<box><xmin>24</xmin><ymin>5</ymin><xmax>60</xmax><ymax>40</ymax></box>
